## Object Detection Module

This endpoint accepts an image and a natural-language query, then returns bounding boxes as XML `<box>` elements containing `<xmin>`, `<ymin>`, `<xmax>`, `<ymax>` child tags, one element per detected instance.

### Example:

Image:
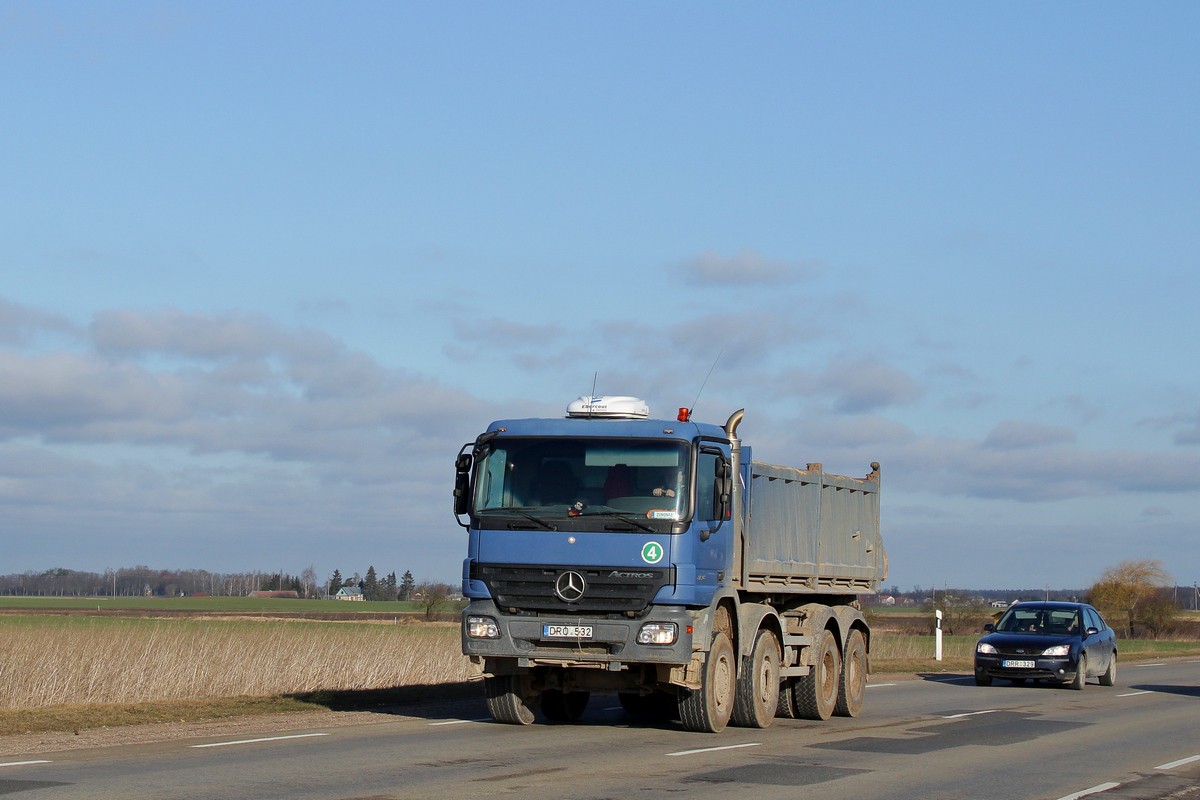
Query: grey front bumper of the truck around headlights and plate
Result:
<box><xmin>462</xmin><ymin>600</ymin><xmax>694</xmax><ymax>672</ymax></box>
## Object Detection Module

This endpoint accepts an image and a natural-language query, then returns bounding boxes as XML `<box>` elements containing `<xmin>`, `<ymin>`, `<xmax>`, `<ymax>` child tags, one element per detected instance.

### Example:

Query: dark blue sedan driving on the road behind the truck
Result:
<box><xmin>976</xmin><ymin>602</ymin><xmax>1117</xmax><ymax>690</ymax></box>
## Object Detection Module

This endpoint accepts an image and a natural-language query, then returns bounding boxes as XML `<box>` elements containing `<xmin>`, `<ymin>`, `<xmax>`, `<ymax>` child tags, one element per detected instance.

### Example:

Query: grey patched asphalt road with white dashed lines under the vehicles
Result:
<box><xmin>0</xmin><ymin>660</ymin><xmax>1200</xmax><ymax>800</ymax></box>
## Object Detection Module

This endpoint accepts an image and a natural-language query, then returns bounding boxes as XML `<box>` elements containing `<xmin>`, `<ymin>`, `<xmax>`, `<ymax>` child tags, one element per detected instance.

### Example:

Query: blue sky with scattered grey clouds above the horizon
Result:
<box><xmin>0</xmin><ymin>2</ymin><xmax>1200</xmax><ymax>589</ymax></box>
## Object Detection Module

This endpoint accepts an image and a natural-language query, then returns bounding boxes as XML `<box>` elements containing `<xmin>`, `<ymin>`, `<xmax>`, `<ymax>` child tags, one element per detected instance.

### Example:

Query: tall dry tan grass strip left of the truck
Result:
<box><xmin>0</xmin><ymin>616</ymin><xmax>467</xmax><ymax>709</ymax></box>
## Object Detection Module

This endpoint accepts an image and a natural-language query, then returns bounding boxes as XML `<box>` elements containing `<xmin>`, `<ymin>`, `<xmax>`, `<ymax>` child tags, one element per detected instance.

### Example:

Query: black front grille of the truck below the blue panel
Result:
<box><xmin>470</xmin><ymin>564</ymin><xmax>674</xmax><ymax>616</ymax></box>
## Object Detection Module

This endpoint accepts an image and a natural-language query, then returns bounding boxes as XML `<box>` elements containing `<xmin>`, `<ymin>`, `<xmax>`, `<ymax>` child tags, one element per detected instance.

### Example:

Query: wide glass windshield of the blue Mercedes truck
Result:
<box><xmin>475</xmin><ymin>437</ymin><xmax>690</xmax><ymax>519</ymax></box>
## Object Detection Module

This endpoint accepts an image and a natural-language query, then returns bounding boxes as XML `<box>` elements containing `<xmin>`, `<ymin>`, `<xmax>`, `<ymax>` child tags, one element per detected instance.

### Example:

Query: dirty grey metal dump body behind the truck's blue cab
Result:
<box><xmin>743</xmin><ymin>462</ymin><xmax>888</xmax><ymax>595</ymax></box>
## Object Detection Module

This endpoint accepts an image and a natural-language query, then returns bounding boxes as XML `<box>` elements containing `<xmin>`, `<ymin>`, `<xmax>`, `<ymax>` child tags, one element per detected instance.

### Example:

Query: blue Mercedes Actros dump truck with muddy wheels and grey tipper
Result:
<box><xmin>454</xmin><ymin>397</ymin><xmax>888</xmax><ymax>733</ymax></box>
